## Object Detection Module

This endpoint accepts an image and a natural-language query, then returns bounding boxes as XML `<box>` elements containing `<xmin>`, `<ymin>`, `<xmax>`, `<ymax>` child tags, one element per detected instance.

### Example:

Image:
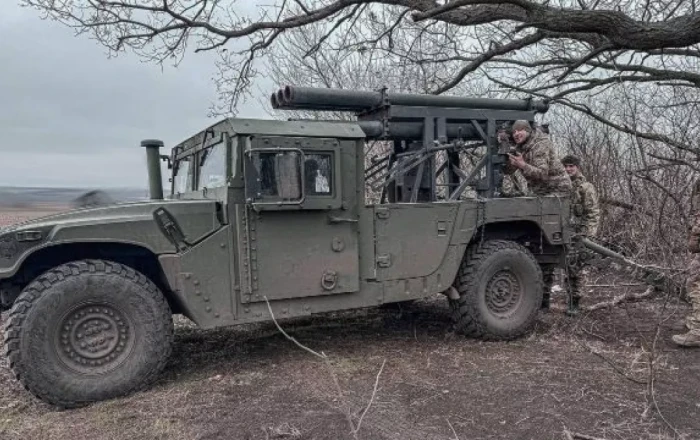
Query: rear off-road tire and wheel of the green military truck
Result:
<box><xmin>450</xmin><ymin>240</ymin><xmax>543</xmax><ymax>340</ymax></box>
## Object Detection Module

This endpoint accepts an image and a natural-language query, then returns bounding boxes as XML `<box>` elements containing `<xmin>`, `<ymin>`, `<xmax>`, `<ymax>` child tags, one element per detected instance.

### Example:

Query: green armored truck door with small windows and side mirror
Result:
<box><xmin>239</xmin><ymin>136</ymin><xmax>359</xmax><ymax>303</ymax></box>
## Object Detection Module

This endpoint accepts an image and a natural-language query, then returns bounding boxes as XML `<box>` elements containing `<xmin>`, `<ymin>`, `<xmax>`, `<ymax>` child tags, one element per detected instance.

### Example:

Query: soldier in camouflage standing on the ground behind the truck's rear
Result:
<box><xmin>556</xmin><ymin>155</ymin><xmax>600</xmax><ymax>316</ymax></box>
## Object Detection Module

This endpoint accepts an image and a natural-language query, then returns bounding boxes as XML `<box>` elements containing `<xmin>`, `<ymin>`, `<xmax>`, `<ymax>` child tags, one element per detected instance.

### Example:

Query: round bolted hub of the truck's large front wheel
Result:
<box><xmin>58</xmin><ymin>305</ymin><xmax>134</xmax><ymax>374</ymax></box>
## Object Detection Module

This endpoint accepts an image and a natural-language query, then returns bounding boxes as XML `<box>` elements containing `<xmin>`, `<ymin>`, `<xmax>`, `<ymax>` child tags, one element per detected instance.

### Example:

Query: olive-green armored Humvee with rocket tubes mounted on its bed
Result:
<box><xmin>0</xmin><ymin>86</ymin><xmax>571</xmax><ymax>407</ymax></box>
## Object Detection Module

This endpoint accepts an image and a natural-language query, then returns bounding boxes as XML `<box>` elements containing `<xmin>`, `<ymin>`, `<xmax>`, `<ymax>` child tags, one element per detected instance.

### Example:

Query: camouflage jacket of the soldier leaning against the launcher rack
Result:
<box><xmin>504</xmin><ymin>130</ymin><xmax>571</xmax><ymax>196</ymax></box>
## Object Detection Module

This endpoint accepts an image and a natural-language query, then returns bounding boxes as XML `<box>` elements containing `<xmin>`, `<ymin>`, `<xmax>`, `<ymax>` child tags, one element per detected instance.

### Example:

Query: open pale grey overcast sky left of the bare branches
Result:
<box><xmin>0</xmin><ymin>0</ymin><xmax>267</xmax><ymax>188</ymax></box>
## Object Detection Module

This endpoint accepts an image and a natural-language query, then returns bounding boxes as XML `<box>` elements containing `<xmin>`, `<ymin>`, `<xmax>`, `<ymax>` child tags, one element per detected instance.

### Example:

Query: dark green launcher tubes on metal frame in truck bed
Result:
<box><xmin>271</xmin><ymin>86</ymin><xmax>548</xmax><ymax>203</ymax></box>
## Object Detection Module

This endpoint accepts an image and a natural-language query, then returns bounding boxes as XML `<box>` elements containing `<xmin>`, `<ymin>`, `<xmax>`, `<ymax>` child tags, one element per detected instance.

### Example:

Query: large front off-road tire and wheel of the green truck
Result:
<box><xmin>4</xmin><ymin>260</ymin><xmax>173</xmax><ymax>408</ymax></box>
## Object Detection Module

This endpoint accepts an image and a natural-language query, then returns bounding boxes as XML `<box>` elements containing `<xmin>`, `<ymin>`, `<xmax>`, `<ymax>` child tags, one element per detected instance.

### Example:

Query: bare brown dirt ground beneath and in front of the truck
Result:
<box><xmin>0</xmin><ymin>208</ymin><xmax>700</xmax><ymax>440</ymax></box>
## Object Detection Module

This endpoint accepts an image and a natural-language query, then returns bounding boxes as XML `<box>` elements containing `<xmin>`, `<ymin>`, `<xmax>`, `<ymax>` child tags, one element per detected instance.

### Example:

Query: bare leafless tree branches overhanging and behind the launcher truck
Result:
<box><xmin>21</xmin><ymin>0</ymin><xmax>700</xmax><ymax>262</ymax></box>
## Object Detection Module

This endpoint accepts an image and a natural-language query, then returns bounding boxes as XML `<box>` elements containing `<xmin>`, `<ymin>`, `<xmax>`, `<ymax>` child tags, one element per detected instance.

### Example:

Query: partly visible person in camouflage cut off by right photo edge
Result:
<box><xmin>671</xmin><ymin>180</ymin><xmax>700</xmax><ymax>347</ymax></box>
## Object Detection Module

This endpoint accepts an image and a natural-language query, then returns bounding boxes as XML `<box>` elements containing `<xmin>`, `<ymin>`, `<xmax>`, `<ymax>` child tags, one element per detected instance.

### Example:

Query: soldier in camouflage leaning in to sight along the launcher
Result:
<box><xmin>498</xmin><ymin>120</ymin><xmax>571</xmax><ymax>196</ymax></box>
